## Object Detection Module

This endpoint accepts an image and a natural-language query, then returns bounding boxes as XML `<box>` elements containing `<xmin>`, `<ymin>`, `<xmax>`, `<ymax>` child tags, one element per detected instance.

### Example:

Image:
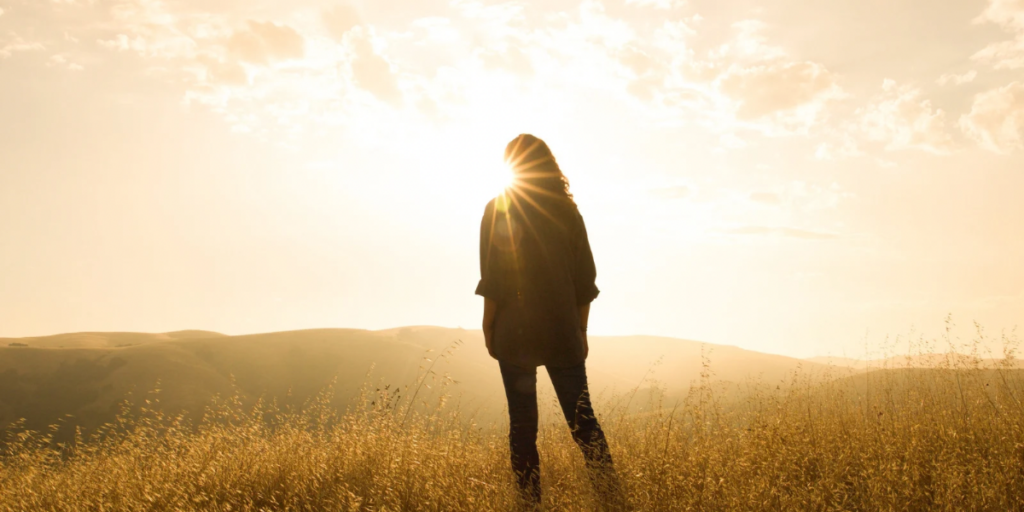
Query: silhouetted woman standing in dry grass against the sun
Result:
<box><xmin>476</xmin><ymin>135</ymin><xmax>620</xmax><ymax>508</ymax></box>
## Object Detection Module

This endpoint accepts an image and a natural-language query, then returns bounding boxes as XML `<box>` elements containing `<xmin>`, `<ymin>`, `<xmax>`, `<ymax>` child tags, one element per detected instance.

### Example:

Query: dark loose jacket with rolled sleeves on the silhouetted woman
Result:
<box><xmin>476</xmin><ymin>195</ymin><xmax>599</xmax><ymax>368</ymax></box>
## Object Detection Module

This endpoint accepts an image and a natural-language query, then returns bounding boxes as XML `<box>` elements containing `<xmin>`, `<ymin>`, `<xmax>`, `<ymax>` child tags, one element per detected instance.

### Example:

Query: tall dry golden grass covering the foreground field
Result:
<box><xmin>0</xmin><ymin>325</ymin><xmax>1024</xmax><ymax>511</ymax></box>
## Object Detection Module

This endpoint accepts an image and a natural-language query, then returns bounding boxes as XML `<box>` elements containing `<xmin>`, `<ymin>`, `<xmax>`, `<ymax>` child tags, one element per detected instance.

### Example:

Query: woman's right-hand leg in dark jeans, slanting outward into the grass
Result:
<box><xmin>548</xmin><ymin>362</ymin><xmax>625</xmax><ymax>510</ymax></box>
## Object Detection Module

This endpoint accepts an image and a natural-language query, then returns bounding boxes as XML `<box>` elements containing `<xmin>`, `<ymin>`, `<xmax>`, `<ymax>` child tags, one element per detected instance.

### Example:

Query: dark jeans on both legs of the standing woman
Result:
<box><xmin>500</xmin><ymin>361</ymin><xmax>621</xmax><ymax>507</ymax></box>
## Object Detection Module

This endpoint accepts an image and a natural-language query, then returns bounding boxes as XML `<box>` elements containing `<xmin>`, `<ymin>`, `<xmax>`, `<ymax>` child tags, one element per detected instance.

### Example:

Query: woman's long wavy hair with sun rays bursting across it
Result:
<box><xmin>505</xmin><ymin>133</ymin><xmax>575</xmax><ymax>206</ymax></box>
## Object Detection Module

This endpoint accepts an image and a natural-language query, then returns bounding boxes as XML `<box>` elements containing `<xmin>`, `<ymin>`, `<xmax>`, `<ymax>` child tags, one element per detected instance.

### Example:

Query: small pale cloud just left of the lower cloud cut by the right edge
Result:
<box><xmin>860</xmin><ymin>80</ymin><xmax>953</xmax><ymax>155</ymax></box>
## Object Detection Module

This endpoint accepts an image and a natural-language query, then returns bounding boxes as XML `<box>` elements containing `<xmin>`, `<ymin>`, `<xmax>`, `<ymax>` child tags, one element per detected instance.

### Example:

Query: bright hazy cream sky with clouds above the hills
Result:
<box><xmin>0</xmin><ymin>0</ymin><xmax>1024</xmax><ymax>356</ymax></box>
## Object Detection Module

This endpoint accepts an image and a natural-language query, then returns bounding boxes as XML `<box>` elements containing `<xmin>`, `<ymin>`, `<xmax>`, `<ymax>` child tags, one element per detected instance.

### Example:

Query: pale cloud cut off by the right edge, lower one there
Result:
<box><xmin>959</xmin><ymin>82</ymin><xmax>1024</xmax><ymax>154</ymax></box>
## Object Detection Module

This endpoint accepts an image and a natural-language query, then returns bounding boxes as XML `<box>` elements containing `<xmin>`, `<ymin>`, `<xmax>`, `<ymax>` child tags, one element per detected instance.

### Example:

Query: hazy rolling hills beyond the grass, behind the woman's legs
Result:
<box><xmin>0</xmin><ymin>327</ymin><xmax>827</xmax><ymax>440</ymax></box>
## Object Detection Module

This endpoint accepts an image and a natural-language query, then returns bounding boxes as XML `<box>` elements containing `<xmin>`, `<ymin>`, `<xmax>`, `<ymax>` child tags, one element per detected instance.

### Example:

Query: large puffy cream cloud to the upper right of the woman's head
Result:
<box><xmin>613</xmin><ymin>15</ymin><xmax>846</xmax><ymax>137</ymax></box>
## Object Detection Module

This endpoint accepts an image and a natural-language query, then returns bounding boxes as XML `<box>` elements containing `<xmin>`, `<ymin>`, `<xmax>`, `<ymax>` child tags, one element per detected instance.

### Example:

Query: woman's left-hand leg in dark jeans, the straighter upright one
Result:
<box><xmin>499</xmin><ymin>361</ymin><xmax>541</xmax><ymax>503</ymax></box>
